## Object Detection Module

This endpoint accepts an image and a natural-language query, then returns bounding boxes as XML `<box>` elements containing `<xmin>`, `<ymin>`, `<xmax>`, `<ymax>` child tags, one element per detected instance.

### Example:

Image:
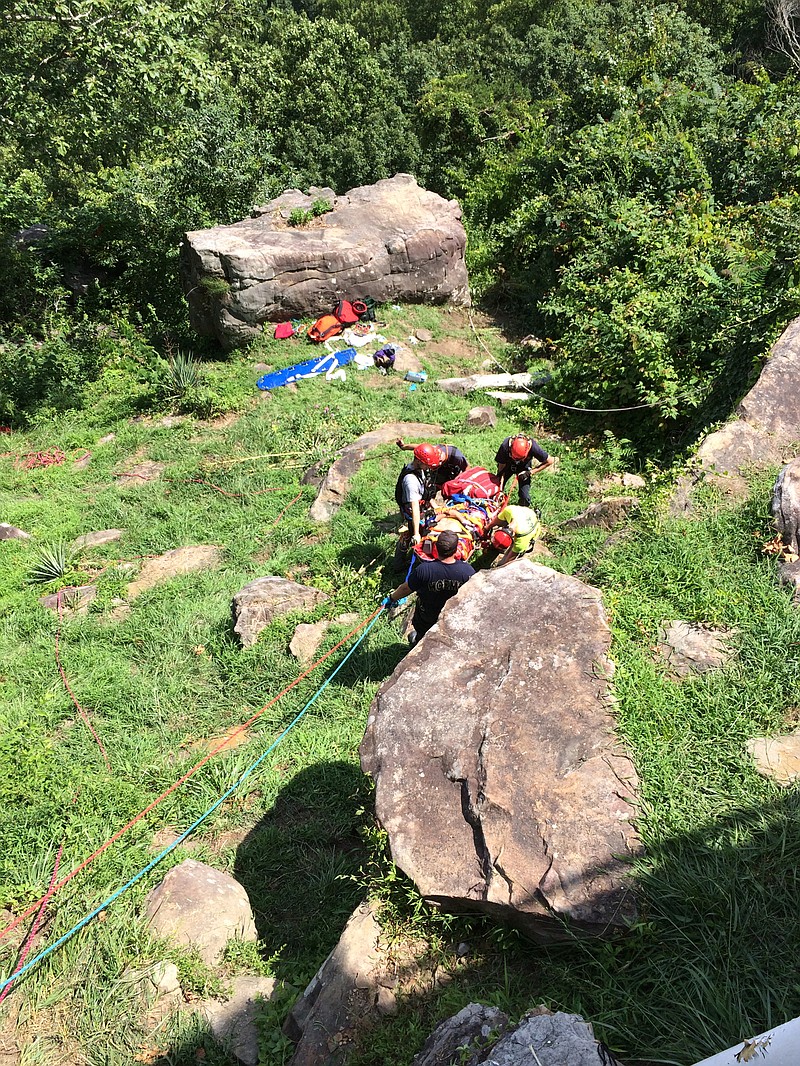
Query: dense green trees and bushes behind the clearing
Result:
<box><xmin>0</xmin><ymin>0</ymin><xmax>800</xmax><ymax>440</ymax></box>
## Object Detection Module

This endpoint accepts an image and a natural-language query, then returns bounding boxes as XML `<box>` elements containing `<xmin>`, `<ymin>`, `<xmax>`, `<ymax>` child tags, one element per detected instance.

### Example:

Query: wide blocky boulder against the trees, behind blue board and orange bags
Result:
<box><xmin>181</xmin><ymin>174</ymin><xmax>469</xmax><ymax>349</ymax></box>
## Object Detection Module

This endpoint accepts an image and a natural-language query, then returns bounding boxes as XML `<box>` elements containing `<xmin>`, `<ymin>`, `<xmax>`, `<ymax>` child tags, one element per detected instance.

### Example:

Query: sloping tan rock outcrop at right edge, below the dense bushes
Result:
<box><xmin>670</xmin><ymin>318</ymin><xmax>800</xmax><ymax>516</ymax></box>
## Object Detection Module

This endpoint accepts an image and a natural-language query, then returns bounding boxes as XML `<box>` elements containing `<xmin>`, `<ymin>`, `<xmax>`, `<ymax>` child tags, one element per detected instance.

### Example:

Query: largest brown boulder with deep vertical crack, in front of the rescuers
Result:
<box><xmin>361</xmin><ymin>560</ymin><xmax>638</xmax><ymax>940</ymax></box>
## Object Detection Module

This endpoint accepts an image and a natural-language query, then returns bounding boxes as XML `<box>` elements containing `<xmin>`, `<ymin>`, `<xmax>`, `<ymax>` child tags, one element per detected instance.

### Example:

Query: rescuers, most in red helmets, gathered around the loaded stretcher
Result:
<box><xmin>387</xmin><ymin>433</ymin><xmax>555</xmax><ymax>645</ymax></box>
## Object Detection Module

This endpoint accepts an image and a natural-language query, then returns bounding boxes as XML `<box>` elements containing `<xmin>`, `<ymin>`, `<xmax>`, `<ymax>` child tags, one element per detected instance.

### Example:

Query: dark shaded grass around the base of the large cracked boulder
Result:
<box><xmin>157</xmin><ymin>776</ymin><xmax>800</xmax><ymax>1066</ymax></box>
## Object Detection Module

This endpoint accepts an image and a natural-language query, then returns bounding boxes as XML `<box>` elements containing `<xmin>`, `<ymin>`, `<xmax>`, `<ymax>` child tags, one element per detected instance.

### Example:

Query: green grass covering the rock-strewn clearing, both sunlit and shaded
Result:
<box><xmin>0</xmin><ymin>308</ymin><xmax>800</xmax><ymax>1066</ymax></box>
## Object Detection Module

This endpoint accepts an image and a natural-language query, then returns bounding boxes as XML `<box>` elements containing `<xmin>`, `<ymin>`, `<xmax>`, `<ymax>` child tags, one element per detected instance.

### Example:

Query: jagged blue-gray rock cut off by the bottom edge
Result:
<box><xmin>413</xmin><ymin>1003</ymin><xmax>617</xmax><ymax>1066</ymax></box>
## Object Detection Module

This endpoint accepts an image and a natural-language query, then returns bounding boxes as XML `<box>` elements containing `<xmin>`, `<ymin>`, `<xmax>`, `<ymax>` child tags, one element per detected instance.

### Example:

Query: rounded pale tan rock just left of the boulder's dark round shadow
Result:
<box><xmin>145</xmin><ymin>859</ymin><xmax>258</xmax><ymax>966</ymax></box>
